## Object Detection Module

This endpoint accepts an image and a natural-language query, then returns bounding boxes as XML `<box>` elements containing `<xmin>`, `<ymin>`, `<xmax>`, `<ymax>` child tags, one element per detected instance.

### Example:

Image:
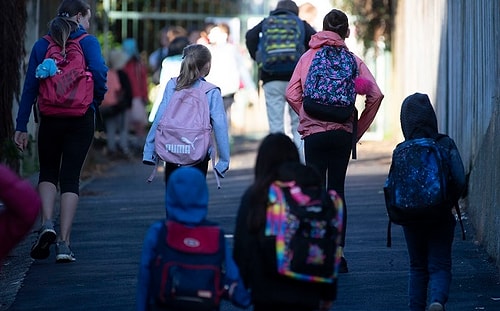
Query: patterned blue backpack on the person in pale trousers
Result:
<box><xmin>256</xmin><ymin>14</ymin><xmax>305</xmax><ymax>75</ymax></box>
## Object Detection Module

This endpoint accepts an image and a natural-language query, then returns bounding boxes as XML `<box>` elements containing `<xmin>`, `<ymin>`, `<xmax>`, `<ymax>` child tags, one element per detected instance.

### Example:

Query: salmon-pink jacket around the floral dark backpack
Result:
<box><xmin>286</xmin><ymin>31</ymin><xmax>384</xmax><ymax>140</ymax></box>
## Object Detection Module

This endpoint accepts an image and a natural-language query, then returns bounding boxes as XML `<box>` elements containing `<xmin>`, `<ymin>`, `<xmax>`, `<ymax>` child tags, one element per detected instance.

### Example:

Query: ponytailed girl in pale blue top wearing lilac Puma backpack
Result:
<box><xmin>143</xmin><ymin>44</ymin><xmax>230</xmax><ymax>188</ymax></box>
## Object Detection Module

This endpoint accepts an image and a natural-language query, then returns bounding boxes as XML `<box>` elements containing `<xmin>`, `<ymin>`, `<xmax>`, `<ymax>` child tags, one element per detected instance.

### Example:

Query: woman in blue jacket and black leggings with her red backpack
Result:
<box><xmin>14</xmin><ymin>0</ymin><xmax>108</xmax><ymax>262</ymax></box>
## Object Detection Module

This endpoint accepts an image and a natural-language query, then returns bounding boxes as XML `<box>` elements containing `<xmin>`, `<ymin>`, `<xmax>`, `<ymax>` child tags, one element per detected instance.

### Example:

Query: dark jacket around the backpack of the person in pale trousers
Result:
<box><xmin>245</xmin><ymin>9</ymin><xmax>316</xmax><ymax>83</ymax></box>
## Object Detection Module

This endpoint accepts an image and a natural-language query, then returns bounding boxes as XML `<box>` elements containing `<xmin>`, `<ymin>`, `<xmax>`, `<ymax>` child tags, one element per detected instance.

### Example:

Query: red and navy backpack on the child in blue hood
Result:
<box><xmin>150</xmin><ymin>221</ymin><xmax>226</xmax><ymax>311</ymax></box>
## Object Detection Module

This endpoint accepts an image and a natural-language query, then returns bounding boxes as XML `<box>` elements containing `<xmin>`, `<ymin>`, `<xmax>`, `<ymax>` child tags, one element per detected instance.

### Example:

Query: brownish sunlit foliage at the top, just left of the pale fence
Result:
<box><xmin>332</xmin><ymin>0</ymin><xmax>395</xmax><ymax>52</ymax></box>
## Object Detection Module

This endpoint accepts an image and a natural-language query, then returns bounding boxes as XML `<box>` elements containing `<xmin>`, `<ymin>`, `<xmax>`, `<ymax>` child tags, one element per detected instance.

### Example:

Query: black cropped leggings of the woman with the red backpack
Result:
<box><xmin>38</xmin><ymin>108</ymin><xmax>95</xmax><ymax>194</ymax></box>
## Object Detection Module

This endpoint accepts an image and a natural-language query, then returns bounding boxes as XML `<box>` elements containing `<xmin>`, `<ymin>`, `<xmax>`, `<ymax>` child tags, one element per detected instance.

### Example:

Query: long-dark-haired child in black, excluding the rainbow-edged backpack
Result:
<box><xmin>233</xmin><ymin>133</ymin><xmax>336</xmax><ymax>311</ymax></box>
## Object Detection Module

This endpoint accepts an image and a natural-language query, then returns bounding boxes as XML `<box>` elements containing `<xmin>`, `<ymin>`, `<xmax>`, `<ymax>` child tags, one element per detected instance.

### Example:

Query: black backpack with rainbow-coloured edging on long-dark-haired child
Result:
<box><xmin>264</xmin><ymin>164</ymin><xmax>343</xmax><ymax>283</ymax></box>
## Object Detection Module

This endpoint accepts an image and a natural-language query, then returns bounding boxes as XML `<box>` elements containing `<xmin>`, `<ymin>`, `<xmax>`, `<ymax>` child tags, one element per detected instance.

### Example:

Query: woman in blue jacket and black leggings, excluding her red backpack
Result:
<box><xmin>14</xmin><ymin>0</ymin><xmax>108</xmax><ymax>262</ymax></box>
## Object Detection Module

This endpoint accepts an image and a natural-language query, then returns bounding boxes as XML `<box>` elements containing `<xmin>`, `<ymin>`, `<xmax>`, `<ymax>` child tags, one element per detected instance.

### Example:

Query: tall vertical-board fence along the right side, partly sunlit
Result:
<box><xmin>392</xmin><ymin>0</ymin><xmax>500</xmax><ymax>266</ymax></box>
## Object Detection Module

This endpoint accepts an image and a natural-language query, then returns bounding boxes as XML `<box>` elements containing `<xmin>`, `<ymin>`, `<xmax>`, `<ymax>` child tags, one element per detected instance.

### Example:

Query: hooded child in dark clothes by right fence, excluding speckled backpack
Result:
<box><xmin>401</xmin><ymin>93</ymin><xmax>465</xmax><ymax>311</ymax></box>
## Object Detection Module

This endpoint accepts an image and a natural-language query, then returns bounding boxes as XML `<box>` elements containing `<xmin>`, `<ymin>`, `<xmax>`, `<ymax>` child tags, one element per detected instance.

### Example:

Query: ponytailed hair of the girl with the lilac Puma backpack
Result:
<box><xmin>175</xmin><ymin>44</ymin><xmax>212</xmax><ymax>91</ymax></box>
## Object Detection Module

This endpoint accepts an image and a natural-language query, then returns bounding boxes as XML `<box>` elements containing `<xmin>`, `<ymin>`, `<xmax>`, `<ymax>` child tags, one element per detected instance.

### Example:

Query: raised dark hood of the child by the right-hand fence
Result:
<box><xmin>400</xmin><ymin>93</ymin><xmax>438</xmax><ymax>140</ymax></box>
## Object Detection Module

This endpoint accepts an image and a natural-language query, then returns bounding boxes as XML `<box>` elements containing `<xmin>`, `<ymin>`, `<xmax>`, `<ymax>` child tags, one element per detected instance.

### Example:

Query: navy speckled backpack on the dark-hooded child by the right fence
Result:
<box><xmin>384</xmin><ymin>138</ymin><xmax>454</xmax><ymax>225</ymax></box>
